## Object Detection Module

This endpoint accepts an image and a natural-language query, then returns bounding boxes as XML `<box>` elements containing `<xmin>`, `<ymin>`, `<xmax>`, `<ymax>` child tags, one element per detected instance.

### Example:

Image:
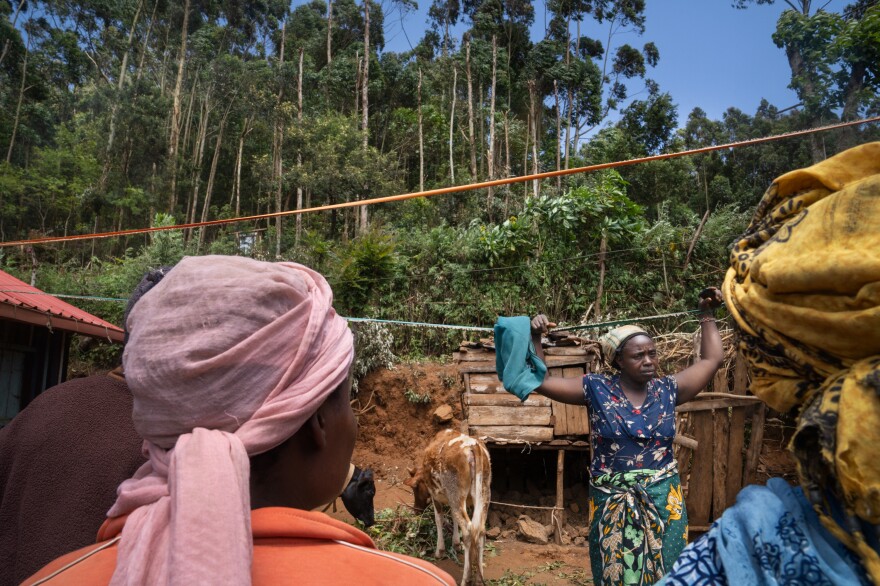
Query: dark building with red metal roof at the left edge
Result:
<box><xmin>0</xmin><ymin>271</ymin><xmax>124</xmax><ymax>427</ymax></box>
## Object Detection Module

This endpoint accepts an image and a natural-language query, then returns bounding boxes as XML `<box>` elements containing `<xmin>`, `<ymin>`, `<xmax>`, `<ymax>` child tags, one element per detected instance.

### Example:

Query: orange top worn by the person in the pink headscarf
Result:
<box><xmin>24</xmin><ymin>507</ymin><xmax>455</xmax><ymax>586</ymax></box>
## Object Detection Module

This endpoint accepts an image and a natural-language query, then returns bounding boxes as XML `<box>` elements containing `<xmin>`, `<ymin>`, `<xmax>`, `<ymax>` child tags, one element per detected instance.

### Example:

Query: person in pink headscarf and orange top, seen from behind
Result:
<box><xmin>26</xmin><ymin>256</ymin><xmax>453</xmax><ymax>586</ymax></box>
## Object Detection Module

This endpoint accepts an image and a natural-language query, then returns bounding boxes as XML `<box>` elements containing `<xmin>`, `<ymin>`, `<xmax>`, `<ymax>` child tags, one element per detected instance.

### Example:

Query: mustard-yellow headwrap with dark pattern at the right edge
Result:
<box><xmin>724</xmin><ymin>142</ymin><xmax>880</xmax><ymax>583</ymax></box>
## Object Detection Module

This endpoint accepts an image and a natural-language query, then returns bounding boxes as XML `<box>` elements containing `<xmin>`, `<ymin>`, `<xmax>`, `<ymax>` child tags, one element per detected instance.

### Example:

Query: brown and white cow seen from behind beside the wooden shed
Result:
<box><xmin>404</xmin><ymin>429</ymin><xmax>492</xmax><ymax>586</ymax></box>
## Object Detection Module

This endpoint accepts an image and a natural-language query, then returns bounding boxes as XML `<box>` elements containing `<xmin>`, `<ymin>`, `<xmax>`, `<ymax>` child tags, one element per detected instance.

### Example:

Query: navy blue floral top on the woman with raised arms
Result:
<box><xmin>584</xmin><ymin>374</ymin><xmax>678</xmax><ymax>476</ymax></box>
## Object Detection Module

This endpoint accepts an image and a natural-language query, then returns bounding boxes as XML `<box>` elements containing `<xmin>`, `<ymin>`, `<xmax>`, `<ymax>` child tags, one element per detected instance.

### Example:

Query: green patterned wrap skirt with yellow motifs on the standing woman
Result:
<box><xmin>590</xmin><ymin>464</ymin><xmax>688</xmax><ymax>586</ymax></box>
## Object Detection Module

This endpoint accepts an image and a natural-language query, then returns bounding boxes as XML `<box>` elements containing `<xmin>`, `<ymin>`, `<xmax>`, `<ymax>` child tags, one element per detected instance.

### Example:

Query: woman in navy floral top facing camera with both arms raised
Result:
<box><xmin>531</xmin><ymin>287</ymin><xmax>724</xmax><ymax>585</ymax></box>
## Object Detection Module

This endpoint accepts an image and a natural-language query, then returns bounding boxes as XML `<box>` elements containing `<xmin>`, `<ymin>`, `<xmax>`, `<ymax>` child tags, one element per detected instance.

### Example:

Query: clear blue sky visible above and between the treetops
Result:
<box><xmin>383</xmin><ymin>0</ymin><xmax>848</xmax><ymax>125</ymax></box>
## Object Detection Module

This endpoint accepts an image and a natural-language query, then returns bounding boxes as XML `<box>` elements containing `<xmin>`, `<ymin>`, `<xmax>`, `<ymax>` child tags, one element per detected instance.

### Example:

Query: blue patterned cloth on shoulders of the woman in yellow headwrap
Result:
<box><xmin>658</xmin><ymin>478</ymin><xmax>870</xmax><ymax>586</ymax></box>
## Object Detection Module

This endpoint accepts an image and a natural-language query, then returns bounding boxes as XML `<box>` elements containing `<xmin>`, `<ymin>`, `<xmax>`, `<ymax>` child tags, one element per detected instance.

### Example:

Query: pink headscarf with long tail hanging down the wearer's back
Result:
<box><xmin>108</xmin><ymin>256</ymin><xmax>354</xmax><ymax>586</ymax></box>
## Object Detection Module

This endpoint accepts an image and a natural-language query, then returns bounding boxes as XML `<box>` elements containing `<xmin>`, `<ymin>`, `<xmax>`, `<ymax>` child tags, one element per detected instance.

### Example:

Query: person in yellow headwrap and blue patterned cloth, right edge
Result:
<box><xmin>667</xmin><ymin>142</ymin><xmax>880</xmax><ymax>585</ymax></box>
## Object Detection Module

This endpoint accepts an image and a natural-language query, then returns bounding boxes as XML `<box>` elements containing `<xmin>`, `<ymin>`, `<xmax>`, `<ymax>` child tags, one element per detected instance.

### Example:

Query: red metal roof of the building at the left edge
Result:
<box><xmin>0</xmin><ymin>271</ymin><xmax>125</xmax><ymax>342</ymax></box>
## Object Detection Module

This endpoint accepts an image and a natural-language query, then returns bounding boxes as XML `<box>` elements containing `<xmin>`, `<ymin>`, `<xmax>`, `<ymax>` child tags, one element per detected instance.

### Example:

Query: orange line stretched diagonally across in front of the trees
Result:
<box><xmin>0</xmin><ymin>116</ymin><xmax>880</xmax><ymax>248</ymax></box>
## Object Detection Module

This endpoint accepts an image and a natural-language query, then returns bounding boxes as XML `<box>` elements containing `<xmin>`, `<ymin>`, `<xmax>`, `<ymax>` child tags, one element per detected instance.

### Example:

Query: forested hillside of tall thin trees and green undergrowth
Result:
<box><xmin>0</xmin><ymin>0</ymin><xmax>880</xmax><ymax>360</ymax></box>
